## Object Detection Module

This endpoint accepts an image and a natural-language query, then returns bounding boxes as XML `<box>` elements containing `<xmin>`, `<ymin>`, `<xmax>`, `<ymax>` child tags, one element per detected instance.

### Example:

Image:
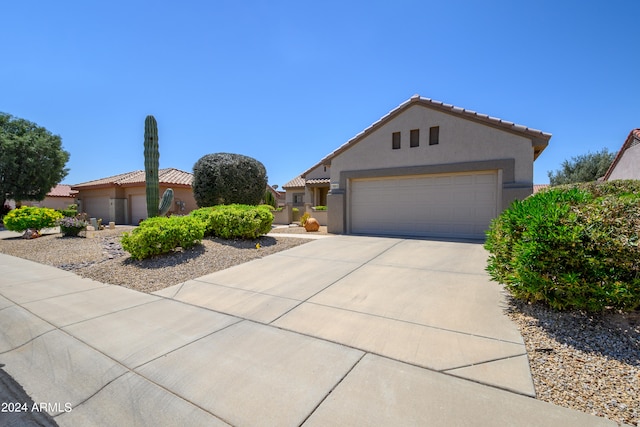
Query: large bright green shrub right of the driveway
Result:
<box><xmin>485</xmin><ymin>181</ymin><xmax>640</xmax><ymax>312</ymax></box>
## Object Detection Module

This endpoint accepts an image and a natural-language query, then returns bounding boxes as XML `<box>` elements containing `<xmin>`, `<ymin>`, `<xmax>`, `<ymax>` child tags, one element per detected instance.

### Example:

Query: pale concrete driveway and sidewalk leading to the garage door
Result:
<box><xmin>0</xmin><ymin>236</ymin><xmax>617</xmax><ymax>426</ymax></box>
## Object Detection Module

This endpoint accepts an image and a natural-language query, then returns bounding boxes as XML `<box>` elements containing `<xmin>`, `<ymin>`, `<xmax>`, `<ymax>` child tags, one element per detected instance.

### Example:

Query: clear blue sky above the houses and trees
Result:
<box><xmin>0</xmin><ymin>0</ymin><xmax>640</xmax><ymax>186</ymax></box>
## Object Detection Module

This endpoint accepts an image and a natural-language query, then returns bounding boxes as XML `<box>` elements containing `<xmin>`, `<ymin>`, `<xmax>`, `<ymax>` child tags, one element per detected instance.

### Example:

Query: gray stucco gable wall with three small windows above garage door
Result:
<box><xmin>331</xmin><ymin>105</ymin><xmax>533</xmax><ymax>184</ymax></box>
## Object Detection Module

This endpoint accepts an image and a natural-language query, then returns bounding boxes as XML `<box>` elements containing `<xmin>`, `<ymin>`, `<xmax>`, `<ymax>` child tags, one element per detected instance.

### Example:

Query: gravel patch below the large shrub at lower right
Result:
<box><xmin>507</xmin><ymin>300</ymin><xmax>640</xmax><ymax>426</ymax></box>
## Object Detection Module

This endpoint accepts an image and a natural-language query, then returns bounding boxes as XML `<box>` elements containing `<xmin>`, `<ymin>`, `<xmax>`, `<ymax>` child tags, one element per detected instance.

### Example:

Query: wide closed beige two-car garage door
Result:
<box><xmin>348</xmin><ymin>171</ymin><xmax>499</xmax><ymax>239</ymax></box>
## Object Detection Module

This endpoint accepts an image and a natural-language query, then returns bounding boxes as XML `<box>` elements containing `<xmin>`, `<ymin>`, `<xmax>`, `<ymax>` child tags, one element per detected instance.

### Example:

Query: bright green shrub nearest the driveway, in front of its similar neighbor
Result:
<box><xmin>121</xmin><ymin>216</ymin><xmax>204</xmax><ymax>260</ymax></box>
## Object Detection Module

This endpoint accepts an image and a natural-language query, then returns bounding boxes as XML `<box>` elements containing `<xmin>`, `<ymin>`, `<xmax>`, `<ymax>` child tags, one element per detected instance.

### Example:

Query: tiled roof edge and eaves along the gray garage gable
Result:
<box><xmin>302</xmin><ymin>95</ymin><xmax>551</xmax><ymax>176</ymax></box>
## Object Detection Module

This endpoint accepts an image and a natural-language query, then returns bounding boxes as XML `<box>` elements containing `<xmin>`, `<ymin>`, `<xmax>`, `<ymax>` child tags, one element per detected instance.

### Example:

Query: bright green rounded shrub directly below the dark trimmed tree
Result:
<box><xmin>191</xmin><ymin>204</ymin><xmax>273</xmax><ymax>239</ymax></box>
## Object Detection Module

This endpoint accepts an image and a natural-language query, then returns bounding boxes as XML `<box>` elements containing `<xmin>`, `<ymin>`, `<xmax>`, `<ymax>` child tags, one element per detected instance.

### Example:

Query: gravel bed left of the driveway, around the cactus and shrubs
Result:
<box><xmin>0</xmin><ymin>227</ymin><xmax>310</xmax><ymax>292</ymax></box>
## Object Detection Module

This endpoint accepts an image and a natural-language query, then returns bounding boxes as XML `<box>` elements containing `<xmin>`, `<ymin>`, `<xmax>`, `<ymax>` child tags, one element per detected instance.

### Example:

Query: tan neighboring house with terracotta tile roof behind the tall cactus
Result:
<box><xmin>72</xmin><ymin>168</ymin><xmax>197</xmax><ymax>225</ymax></box>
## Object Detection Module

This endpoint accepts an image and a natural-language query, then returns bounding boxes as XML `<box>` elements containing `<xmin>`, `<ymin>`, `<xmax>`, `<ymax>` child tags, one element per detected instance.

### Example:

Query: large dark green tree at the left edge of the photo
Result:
<box><xmin>0</xmin><ymin>113</ymin><xmax>69</xmax><ymax>202</ymax></box>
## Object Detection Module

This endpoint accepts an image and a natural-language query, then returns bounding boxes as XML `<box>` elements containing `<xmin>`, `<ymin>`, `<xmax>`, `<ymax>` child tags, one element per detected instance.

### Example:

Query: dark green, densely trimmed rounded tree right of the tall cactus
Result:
<box><xmin>193</xmin><ymin>153</ymin><xmax>267</xmax><ymax>207</ymax></box>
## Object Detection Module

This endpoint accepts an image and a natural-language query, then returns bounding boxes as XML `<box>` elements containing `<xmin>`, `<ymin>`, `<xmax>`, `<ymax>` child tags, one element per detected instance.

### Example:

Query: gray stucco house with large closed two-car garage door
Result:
<box><xmin>283</xmin><ymin>95</ymin><xmax>551</xmax><ymax>238</ymax></box>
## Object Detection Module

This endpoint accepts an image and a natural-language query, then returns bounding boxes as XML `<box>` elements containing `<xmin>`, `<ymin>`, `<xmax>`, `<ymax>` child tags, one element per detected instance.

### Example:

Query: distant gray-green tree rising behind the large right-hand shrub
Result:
<box><xmin>547</xmin><ymin>148</ymin><xmax>615</xmax><ymax>185</ymax></box>
